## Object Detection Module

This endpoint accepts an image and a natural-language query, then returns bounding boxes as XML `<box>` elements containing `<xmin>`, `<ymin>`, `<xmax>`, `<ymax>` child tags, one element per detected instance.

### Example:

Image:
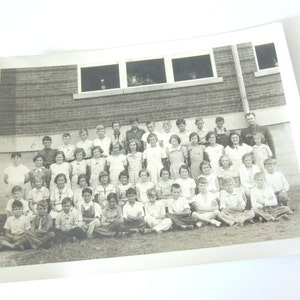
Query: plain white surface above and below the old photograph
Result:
<box><xmin>0</xmin><ymin>0</ymin><xmax>300</xmax><ymax>299</ymax></box>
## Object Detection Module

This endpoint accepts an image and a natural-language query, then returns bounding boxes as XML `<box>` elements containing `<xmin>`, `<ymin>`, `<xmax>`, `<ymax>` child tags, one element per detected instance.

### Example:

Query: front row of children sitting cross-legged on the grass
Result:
<box><xmin>0</xmin><ymin>166</ymin><xmax>293</xmax><ymax>250</ymax></box>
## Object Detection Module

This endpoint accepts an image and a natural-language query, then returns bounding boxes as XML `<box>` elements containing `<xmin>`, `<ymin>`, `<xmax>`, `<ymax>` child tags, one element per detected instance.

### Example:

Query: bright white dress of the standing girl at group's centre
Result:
<box><xmin>143</xmin><ymin>146</ymin><xmax>167</xmax><ymax>184</ymax></box>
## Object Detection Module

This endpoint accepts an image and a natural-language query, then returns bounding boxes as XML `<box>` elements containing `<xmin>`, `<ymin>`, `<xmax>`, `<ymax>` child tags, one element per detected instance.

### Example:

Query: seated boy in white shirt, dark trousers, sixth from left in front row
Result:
<box><xmin>121</xmin><ymin>188</ymin><xmax>146</xmax><ymax>233</ymax></box>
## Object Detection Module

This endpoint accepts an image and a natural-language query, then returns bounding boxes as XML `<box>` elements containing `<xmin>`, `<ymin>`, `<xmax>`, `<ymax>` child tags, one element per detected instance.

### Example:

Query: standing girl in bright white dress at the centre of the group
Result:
<box><xmin>143</xmin><ymin>133</ymin><xmax>167</xmax><ymax>184</ymax></box>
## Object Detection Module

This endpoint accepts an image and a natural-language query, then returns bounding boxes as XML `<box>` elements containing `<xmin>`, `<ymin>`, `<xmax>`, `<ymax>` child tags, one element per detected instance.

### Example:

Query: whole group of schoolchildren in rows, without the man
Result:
<box><xmin>0</xmin><ymin>117</ymin><xmax>293</xmax><ymax>250</ymax></box>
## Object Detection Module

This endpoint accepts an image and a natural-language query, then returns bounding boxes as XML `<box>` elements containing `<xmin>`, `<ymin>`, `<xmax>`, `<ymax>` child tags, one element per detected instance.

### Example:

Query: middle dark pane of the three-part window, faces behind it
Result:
<box><xmin>126</xmin><ymin>58</ymin><xmax>166</xmax><ymax>87</ymax></box>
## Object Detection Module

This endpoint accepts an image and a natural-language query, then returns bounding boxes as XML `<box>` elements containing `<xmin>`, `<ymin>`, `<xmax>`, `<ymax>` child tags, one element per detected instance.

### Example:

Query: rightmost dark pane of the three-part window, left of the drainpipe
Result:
<box><xmin>172</xmin><ymin>54</ymin><xmax>214</xmax><ymax>82</ymax></box>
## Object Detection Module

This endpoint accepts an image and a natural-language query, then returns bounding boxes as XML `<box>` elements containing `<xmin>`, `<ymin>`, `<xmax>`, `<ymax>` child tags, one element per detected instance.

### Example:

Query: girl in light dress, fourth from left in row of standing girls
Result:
<box><xmin>87</xmin><ymin>146</ymin><xmax>106</xmax><ymax>190</ymax></box>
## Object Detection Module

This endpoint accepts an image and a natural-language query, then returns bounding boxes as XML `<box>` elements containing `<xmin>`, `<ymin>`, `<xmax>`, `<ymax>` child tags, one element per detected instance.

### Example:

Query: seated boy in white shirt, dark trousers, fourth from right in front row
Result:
<box><xmin>167</xmin><ymin>183</ymin><xmax>200</xmax><ymax>229</ymax></box>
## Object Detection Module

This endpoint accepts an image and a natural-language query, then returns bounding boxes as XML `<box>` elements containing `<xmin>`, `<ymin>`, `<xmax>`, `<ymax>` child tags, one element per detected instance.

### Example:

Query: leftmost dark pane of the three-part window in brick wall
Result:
<box><xmin>81</xmin><ymin>65</ymin><xmax>120</xmax><ymax>92</ymax></box>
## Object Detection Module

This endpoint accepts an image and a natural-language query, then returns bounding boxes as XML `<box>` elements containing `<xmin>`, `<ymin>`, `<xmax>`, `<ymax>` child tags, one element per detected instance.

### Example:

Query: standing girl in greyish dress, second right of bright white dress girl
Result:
<box><xmin>188</xmin><ymin>132</ymin><xmax>207</xmax><ymax>181</ymax></box>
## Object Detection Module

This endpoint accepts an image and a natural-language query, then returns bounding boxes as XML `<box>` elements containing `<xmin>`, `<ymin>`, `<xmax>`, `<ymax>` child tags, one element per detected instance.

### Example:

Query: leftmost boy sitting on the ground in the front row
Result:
<box><xmin>0</xmin><ymin>200</ymin><xmax>30</xmax><ymax>250</ymax></box>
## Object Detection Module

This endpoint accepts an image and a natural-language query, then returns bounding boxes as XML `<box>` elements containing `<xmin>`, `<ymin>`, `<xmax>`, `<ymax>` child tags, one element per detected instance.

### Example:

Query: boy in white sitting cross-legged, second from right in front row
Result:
<box><xmin>219</xmin><ymin>177</ymin><xmax>255</xmax><ymax>226</ymax></box>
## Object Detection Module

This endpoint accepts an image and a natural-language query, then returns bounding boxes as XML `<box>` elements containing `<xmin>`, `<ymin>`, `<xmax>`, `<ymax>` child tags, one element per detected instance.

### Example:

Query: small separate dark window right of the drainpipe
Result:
<box><xmin>255</xmin><ymin>43</ymin><xmax>278</xmax><ymax>70</ymax></box>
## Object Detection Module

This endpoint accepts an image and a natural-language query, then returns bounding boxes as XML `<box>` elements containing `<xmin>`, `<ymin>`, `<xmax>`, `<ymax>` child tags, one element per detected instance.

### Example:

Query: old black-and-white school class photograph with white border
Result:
<box><xmin>0</xmin><ymin>24</ymin><xmax>300</xmax><ymax>278</ymax></box>
